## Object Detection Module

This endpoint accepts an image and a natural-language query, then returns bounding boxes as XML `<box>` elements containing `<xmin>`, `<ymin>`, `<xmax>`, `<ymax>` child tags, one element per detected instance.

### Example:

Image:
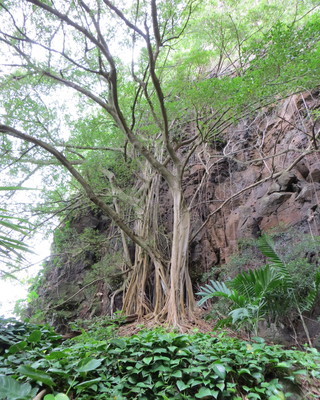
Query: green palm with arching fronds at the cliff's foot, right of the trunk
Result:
<box><xmin>198</xmin><ymin>235</ymin><xmax>320</xmax><ymax>345</ymax></box>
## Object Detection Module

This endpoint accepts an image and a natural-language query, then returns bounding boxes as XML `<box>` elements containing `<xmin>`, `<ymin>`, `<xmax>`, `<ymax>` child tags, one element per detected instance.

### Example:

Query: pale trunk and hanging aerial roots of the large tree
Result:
<box><xmin>123</xmin><ymin>169</ymin><xmax>195</xmax><ymax>326</ymax></box>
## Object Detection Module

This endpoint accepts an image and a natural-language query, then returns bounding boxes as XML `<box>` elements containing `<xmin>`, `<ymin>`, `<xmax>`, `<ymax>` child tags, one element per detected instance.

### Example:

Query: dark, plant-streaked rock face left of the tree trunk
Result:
<box><xmin>30</xmin><ymin>207</ymin><xmax>121</xmax><ymax>333</ymax></box>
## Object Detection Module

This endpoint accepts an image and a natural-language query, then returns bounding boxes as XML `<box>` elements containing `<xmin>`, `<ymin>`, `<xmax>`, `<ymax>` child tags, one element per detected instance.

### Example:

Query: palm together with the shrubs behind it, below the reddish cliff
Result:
<box><xmin>198</xmin><ymin>232</ymin><xmax>320</xmax><ymax>346</ymax></box>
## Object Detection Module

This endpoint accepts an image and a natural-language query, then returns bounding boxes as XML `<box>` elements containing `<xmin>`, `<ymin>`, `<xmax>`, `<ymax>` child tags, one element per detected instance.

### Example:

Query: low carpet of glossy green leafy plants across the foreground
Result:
<box><xmin>0</xmin><ymin>320</ymin><xmax>320</xmax><ymax>400</ymax></box>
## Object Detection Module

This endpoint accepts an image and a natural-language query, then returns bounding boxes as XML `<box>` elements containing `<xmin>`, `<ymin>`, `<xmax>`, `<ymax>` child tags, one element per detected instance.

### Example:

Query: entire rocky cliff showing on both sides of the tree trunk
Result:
<box><xmin>35</xmin><ymin>90</ymin><xmax>320</xmax><ymax>336</ymax></box>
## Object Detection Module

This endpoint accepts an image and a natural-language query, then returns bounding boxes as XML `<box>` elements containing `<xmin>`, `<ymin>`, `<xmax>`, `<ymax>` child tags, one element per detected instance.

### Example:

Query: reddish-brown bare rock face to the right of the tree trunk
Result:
<box><xmin>186</xmin><ymin>91</ymin><xmax>320</xmax><ymax>269</ymax></box>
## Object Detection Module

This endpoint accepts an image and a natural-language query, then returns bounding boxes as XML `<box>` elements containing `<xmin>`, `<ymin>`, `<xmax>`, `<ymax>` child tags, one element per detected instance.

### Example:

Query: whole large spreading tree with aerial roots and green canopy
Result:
<box><xmin>0</xmin><ymin>0</ymin><xmax>319</xmax><ymax>326</ymax></box>
